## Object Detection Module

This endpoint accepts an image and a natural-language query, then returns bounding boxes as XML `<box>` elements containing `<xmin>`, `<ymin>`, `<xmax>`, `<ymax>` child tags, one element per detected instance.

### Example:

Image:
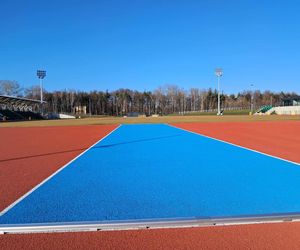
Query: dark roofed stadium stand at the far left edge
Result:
<box><xmin>0</xmin><ymin>95</ymin><xmax>45</xmax><ymax>121</ymax></box>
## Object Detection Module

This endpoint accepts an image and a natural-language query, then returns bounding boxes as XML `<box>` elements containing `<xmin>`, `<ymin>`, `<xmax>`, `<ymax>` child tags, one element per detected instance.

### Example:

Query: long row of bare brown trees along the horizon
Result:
<box><xmin>0</xmin><ymin>80</ymin><xmax>296</xmax><ymax>116</ymax></box>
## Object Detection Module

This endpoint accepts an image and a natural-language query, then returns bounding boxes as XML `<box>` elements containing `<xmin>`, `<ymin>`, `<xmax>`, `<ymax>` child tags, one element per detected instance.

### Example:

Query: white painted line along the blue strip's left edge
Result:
<box><xmin>0</xmin><ymin>125</ymin><xmax>122</xmax><ymax>216</ymax></box>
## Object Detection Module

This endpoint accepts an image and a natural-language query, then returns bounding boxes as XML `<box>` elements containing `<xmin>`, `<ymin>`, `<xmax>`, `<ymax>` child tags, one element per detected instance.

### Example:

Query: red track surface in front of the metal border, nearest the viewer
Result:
<box><xmin>0</xmin><ymin>222</ymin><xmax>300</xmax><ymax>250</ymax></box>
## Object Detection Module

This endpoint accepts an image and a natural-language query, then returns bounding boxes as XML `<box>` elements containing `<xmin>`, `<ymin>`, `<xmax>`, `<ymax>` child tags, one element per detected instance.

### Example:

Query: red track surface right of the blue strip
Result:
<box><xmin>172</xmin><ymin>121</ymin><xmax>300</xmax><ymax>163</ymax></box>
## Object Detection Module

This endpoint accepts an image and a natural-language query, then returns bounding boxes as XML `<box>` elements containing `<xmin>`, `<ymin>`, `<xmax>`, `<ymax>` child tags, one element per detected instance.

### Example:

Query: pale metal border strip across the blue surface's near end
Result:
<box><xmin>0</xmin><ymin>213</ymin><xmax>300</xmax><ymax>234</ymax></box>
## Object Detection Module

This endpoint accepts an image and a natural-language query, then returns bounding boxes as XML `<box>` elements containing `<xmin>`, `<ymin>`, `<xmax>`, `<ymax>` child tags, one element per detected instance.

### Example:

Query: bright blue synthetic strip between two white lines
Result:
<box><xmin>0</xmin><ymin>124</ymin><xmax>300</xmax><ymax>224</ymax></box>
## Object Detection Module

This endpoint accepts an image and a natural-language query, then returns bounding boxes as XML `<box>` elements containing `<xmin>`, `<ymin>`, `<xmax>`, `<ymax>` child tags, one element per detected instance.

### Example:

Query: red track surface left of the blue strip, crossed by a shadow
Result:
<box><xmin>0</xmin><ymin>125</ymin><xmax>117</xmax><ymax>211</ymax></box>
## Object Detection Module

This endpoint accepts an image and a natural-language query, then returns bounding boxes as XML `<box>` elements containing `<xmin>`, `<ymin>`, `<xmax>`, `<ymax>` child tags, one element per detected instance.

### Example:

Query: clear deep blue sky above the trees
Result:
<box><xmin>0</xmin><ymin>0</ymin><xmax>300</xmax><ymax>93</ymax></box>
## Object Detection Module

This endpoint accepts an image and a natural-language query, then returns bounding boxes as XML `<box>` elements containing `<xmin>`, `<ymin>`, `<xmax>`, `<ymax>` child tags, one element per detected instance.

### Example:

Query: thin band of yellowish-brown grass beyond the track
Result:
<box><xmin>0</xmin><ymin>115</ymin><xmax>300</xmax><ymax>127</ymax></box>
